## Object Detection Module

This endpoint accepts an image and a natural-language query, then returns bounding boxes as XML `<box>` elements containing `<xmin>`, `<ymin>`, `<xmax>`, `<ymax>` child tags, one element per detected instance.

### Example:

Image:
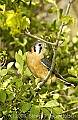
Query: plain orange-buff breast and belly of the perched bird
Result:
<box><xmin>27</xmin><ymin>52</ymin><xmax>48</xmax><ymax>79</ymax></box>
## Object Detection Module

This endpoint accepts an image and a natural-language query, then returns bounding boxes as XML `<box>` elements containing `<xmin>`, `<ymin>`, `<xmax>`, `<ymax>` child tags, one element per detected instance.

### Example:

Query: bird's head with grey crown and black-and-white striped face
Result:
<box><xmin>31</xmin><ymin>41</ymin><xmax>47</xmax><ymax>54</ymax></box>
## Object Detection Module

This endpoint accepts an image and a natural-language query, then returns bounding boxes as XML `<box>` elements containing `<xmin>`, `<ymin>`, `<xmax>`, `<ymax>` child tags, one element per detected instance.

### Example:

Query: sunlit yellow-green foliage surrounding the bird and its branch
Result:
<box><xmin>0</xmin><ymin>0</ymin><xmax>78</xmax><ymax>120</ymax></box>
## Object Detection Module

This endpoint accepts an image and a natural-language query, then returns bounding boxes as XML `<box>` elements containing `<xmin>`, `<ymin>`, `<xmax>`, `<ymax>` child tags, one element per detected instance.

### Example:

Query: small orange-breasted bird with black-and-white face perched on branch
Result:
<box><xmin>27</xmin><ymin>41</ymin><xmax>74</xmax><ymax>85</ymax></box>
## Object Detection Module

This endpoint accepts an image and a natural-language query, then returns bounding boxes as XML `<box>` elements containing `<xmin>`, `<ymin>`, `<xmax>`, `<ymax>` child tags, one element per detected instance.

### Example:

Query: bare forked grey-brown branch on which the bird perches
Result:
<box><xmin>29</xmin><ymin>0</ymin><xmax>75</xmax><ymax>101</ymax></box>
